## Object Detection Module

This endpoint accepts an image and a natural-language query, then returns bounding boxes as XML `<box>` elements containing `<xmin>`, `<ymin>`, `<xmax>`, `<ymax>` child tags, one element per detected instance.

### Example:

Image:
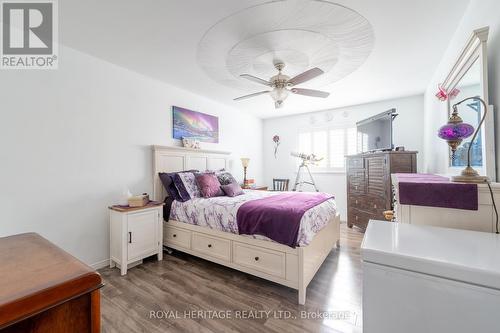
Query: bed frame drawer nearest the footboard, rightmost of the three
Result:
<box><xmin>233</xmin><ymin>242</ymin><xmax>286</xmax><ymax>278</ymax></box>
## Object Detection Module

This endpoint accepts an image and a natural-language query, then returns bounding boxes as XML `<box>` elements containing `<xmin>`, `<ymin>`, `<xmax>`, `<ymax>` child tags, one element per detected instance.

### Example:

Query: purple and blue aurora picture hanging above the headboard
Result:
<box><xmin>172</xmin><ymin>106</ymin><xmax>219</xmax><ymax>143</ymax></box>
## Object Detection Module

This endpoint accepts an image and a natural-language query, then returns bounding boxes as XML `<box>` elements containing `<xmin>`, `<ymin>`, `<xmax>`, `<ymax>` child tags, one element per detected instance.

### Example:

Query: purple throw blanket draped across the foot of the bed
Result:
<box><xmin>236</xmin><ymin>192</ymin><xmax>333</xmax><ymax>247</ymax></box>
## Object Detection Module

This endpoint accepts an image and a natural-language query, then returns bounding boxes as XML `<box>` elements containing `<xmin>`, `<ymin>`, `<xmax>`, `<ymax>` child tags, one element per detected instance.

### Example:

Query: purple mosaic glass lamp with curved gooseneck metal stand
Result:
<box><xmin>438</xmin><ymin>97</ymin><xmax>488</xmax><ymax>183</ymax></box>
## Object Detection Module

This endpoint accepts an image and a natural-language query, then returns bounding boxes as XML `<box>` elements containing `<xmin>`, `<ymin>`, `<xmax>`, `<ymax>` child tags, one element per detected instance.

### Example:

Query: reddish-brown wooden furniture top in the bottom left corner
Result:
<box><xmin>0</xmin><ymin>233</ymin><xmax>102</xmax><ymax>333</ymax></box>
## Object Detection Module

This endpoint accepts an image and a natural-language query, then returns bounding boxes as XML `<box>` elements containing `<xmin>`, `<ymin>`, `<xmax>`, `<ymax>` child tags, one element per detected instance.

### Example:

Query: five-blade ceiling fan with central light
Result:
<box><xmin>234</xmin><ymin>61</ymin><xmax>330</xmax><ymax>109</ymax></box>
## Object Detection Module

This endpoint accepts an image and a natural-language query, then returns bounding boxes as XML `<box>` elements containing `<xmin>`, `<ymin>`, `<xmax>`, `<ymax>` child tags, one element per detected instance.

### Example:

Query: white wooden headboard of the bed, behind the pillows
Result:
<box><xmin>153</xmin><ymin>146</ymin><xmax>231</xmax><ymax>201</ymax></box>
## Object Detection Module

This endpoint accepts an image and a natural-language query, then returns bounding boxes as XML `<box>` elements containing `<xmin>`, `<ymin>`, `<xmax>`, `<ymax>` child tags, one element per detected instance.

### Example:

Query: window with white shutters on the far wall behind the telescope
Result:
<box><xmin>298</xmin><ymin>127</ymin><xmax>361</xmax><ymax>171</ymax></box>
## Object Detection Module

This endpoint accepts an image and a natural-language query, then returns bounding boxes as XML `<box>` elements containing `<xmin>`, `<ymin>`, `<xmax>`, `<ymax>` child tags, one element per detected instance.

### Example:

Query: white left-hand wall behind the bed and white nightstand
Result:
<box><xmin>0</xmin><ymin>47</ymin><xmax>262</xmax><ymax>264</ymax></box>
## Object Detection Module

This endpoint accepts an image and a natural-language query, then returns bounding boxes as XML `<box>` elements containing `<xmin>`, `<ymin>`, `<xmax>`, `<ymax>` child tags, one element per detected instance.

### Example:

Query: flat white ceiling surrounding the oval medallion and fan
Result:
<box><xmin>59</xmin><ymin>0</ymin><xmax>469</xmax><ymax>118</ymax></box>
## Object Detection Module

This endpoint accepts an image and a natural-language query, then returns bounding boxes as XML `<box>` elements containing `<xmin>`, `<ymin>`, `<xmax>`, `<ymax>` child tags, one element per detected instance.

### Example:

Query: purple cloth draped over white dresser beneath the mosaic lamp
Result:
<box><xmin>396</xmin><ymin>173</ymin><xmax>478</xmax><ymax>210</ymax></box>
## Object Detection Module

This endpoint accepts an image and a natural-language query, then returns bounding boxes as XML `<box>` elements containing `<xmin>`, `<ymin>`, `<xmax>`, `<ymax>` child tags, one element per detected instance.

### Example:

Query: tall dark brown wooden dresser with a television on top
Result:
<box><xmin>346</xmin><ymin>151</ymin><xmax>417</xmax><ymax>230</ymax></box>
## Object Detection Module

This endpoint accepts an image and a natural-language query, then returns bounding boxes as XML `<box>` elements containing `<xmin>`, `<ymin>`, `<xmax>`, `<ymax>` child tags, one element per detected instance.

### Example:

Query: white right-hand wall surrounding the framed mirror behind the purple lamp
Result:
<box><xmin>424</xmin><ymin>0</ymin><xmax>500</xmax><ymax>178</ymax></box>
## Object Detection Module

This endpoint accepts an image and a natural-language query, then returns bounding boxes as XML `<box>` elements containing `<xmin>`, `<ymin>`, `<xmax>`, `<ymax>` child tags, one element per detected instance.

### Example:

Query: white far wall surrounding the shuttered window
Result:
<box><xmin>263</xmin><ymin>95</ymin><xmax>423</xmax><ymax>220</ymax></box>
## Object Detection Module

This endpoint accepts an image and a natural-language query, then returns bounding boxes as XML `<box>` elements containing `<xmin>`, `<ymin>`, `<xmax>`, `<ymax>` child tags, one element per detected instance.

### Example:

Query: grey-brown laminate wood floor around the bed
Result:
<box><xmin>99</xmin><ymin>223</ymin><xmax>363</xmax><ymax>333</ymax></box>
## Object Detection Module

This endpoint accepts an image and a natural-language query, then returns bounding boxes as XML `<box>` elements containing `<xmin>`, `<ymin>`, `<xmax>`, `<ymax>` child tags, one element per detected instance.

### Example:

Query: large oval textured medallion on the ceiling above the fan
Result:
<box><xmin>197</xmin><ymin>0</ymin><xmax>374</xmax><ymax>90</ymax></box>
